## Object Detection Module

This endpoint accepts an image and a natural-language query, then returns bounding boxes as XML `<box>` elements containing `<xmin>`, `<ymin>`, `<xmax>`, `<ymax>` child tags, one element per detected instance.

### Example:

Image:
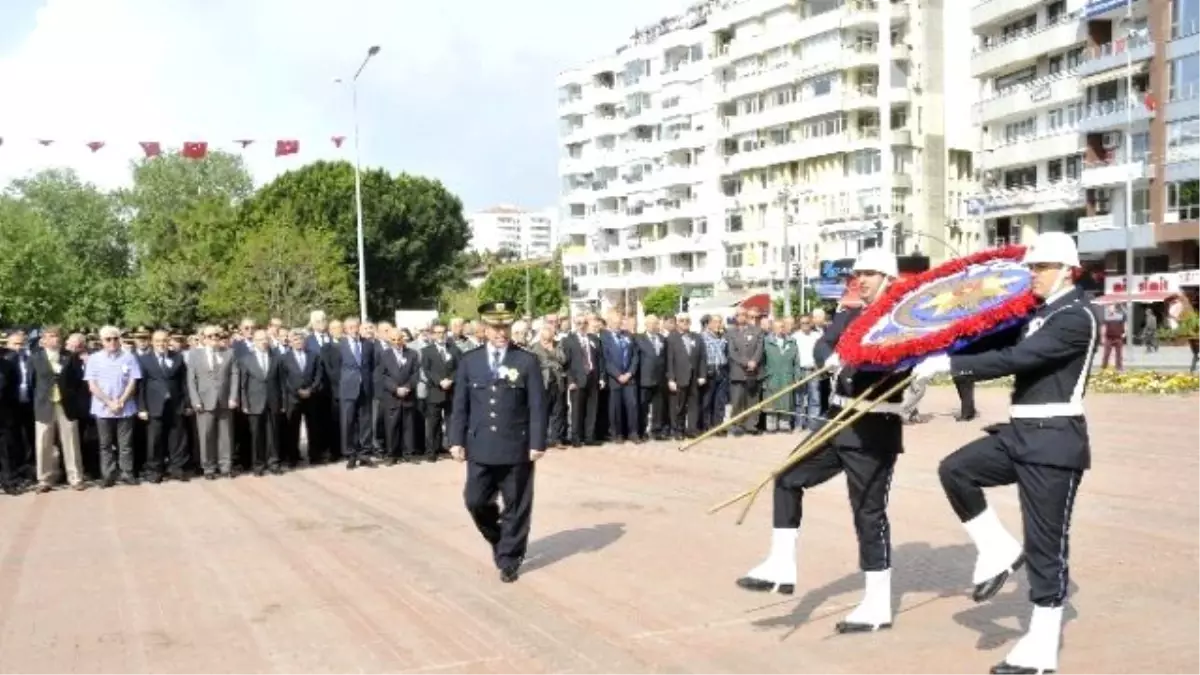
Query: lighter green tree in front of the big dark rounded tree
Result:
<box><xmin>200</xmin><ymin>214</ymin><xmax>355</xmax><ymax>325</ymax></box>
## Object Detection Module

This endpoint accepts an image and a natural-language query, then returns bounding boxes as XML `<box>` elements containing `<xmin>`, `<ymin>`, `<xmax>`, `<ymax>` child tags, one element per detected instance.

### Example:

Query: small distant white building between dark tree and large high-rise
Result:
<box><xmin>467</xmin><ymin>204</ymin><xmax>559</xmax><ymax>259</ymax></box>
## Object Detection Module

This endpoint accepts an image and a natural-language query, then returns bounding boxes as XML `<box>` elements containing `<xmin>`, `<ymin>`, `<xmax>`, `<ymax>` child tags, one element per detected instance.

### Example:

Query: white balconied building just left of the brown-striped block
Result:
<box><xmin>970</xmin><ymin>0</ymin><xmax>1086</xmax><ymax>245</ymax></box>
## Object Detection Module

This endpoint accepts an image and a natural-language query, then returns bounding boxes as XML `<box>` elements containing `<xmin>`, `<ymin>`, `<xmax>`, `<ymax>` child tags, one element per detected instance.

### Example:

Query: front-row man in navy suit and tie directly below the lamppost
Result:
<box><xmin>330</xmin><ymin>317</ymin><xmax>374</xmax><ymax>468</ymax></box>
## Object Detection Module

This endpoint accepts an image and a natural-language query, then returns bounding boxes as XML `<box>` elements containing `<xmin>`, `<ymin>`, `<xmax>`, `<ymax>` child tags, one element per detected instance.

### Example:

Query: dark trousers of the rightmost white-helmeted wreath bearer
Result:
<box><xmin>937</xmin><ymin>432</ymin><xmax>1084</xmax><ymax>607</ymax></box>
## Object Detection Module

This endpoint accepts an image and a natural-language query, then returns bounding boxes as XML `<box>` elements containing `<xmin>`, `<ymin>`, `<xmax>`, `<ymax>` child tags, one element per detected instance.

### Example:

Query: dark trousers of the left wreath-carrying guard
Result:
<box><xmin>774</xmin><ymin>444</ymin><xmax>896</xmax><ymax>572</ymax></box>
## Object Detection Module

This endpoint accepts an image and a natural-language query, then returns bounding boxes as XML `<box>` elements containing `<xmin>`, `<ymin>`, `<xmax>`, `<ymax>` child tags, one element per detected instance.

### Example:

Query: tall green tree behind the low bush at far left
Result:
<box><xmin>8</xmin><ymin>169</ymin><xmax>132</xmax><ymax>327</ymax></box>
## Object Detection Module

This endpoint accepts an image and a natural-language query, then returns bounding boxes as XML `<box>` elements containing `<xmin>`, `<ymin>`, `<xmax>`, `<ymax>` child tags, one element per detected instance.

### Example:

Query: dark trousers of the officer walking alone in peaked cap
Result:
<box><xmin>462</xmin><ymin>461</ymin><xmax>534</xmax><ymax>568</ymax></box>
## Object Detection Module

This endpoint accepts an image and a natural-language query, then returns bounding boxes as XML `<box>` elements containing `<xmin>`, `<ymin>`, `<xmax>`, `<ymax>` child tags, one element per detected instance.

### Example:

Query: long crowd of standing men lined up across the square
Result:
<box><xmin>0</xmin><ymin>302</ymin><xmax>883</xmax><ymax>492</ymax></box>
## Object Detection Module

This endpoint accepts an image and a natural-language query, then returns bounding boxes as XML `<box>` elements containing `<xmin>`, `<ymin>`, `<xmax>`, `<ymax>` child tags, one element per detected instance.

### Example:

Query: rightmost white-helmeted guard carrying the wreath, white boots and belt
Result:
<box><xmin>913</xmin><ymin>232</ymin><xmax>1099</xmax><ymax>675</ymax></box>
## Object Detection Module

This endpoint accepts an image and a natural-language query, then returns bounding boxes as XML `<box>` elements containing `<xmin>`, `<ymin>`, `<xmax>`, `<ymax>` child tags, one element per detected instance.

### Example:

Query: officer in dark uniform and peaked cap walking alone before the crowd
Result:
<box><xmin>448</xmin><ymin>296</ymin><xmax>547</xmax><ymax>584</ymax></box>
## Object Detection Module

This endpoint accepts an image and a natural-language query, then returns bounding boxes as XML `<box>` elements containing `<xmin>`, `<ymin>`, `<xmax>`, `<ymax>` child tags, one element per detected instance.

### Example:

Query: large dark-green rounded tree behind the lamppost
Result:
<box><xmin>245</xmin><ymin>161</ymin><xmax>470</xmax><ymax>316</ymax></box>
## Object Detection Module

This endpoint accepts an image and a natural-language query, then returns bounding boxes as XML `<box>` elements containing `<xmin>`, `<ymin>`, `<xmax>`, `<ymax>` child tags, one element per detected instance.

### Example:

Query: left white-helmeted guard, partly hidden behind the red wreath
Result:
<box><xmin>738</xmin><ymin>249</ymin><xmax>907</xmax><ymax>633</ymax></box>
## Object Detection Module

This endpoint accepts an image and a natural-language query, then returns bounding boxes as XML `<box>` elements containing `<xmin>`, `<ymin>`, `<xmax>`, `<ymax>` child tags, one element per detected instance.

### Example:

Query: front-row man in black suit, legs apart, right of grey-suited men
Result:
<box><xmin>278</xmin><ymin>330</ymin><xmax>329</xmax><ymax>466</ymax></box>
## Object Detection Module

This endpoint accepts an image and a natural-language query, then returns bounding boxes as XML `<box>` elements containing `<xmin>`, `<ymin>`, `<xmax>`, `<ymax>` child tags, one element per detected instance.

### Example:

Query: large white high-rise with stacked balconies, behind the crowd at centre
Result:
<box><xmin>558</xmin><ymin>0</ymin><xmax>982</xmax><ymax>304</ymax></box>
